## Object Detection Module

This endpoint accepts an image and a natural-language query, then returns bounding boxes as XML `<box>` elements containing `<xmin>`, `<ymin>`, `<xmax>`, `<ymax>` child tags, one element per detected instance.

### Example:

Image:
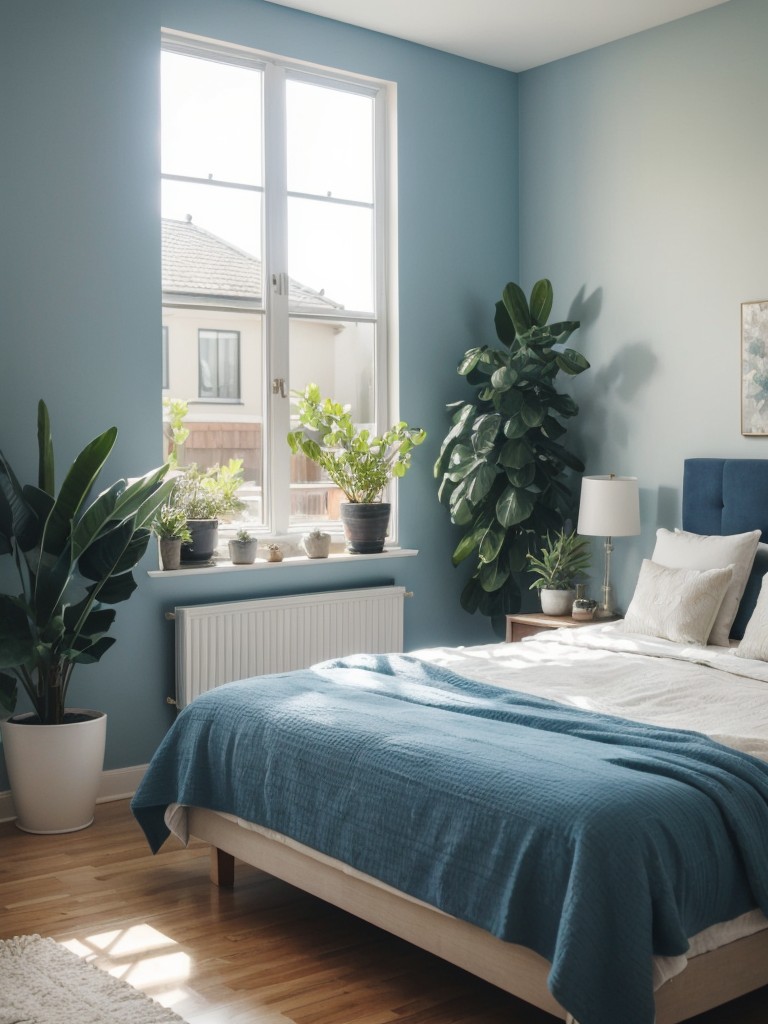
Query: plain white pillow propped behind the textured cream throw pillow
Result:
<box><xmin>651</xmin><ymin>529</ymin><xmax>760</xmax><ymax>647</ymax></box>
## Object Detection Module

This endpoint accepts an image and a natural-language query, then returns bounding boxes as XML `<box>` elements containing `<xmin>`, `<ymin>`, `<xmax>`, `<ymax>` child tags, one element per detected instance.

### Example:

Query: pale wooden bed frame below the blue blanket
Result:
<box><xmin>188</xmin><ymin>807</ymin><xmax>768</xmax><ymax>1024</ymax></box>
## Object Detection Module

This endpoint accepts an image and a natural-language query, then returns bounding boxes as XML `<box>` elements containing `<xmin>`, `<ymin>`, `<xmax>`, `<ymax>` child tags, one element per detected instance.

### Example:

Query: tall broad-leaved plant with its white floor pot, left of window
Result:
<box><xmin>0</xmin><ymin>401</ymin><xmax>171</xmax><ymax>833</ymax></box>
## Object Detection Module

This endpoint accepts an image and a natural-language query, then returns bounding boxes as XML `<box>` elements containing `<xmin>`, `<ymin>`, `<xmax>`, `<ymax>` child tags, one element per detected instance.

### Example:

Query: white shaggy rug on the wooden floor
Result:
<box><xmin>0</xmin><ymin>935</ymin><xmax>181</xmax><ymax>1024</ymax></box>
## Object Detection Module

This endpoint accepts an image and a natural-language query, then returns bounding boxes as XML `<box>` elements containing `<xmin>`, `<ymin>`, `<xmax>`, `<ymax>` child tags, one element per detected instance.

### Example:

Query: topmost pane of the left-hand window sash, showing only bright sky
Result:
<box><xmin>162</xmin><ymin>52</ymin><xmax>263</xmax><ymax>184</ymax></box>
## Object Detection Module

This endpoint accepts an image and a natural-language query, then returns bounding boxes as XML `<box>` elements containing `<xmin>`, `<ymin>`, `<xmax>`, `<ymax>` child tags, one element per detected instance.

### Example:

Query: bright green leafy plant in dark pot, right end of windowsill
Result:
<box><xmin>288</xmin><ymin>384</ymin><xmax>427</xmax><ymax>554</ymax></box>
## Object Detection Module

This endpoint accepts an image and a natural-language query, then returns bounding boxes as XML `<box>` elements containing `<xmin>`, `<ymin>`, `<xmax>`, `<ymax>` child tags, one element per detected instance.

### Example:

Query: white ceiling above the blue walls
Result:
<box><xmin>270</xmin><ymin>0</ymin><xmax>728</xmax><ymax>72</ymax></box>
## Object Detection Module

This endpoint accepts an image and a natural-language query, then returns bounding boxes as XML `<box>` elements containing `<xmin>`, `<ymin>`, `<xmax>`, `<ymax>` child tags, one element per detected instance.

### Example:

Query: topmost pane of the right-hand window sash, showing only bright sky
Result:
<box><xmin>286</xmin><ymin>80</ymin><xmax>374</xmax><ymax>203</ymax></box>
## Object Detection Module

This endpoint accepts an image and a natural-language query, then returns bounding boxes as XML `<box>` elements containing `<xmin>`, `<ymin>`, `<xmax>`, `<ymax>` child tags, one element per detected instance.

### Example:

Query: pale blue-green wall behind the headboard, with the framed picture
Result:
<box><xmin>519</xmin><ymin>0</ymin><xmax>768</xmax><ymax>608</ymax></box>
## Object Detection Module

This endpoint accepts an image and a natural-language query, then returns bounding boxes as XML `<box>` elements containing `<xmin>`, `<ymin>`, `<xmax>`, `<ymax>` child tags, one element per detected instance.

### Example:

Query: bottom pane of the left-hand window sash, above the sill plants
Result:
<box><xmin>163</xmin><ymin>306</ymin><xmax>264</xmax><ymax>526</ymax></box>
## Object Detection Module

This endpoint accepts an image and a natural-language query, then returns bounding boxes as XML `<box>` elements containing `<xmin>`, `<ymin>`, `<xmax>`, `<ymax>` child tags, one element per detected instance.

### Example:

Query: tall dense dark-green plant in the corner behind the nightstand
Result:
<box><xmin>434</xmin><ymin>280</ymin><xmax>589</xmax><ymax>615</ymax></box>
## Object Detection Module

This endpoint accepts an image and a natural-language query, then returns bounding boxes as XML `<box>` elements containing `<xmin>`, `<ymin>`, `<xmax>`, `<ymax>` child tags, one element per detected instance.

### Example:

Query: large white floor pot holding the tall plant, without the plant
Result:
<box><xmin>0</xmin><ymin>708</ymin><xmax>106</xmax><ymax>835</ymax></box>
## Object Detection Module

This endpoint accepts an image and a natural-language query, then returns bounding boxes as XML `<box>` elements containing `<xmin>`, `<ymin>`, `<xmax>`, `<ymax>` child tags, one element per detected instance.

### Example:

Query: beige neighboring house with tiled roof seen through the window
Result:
<box><xmin>163</xmin><ymin>216</ymin><xmax>373</xmax><ymax>518</ymax></box>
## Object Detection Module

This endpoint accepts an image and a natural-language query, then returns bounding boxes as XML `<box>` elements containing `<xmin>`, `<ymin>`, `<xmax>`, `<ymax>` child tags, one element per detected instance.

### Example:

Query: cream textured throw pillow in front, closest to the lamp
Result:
<box><xmin>624</xmin><ymin>558</ymin><xmax>733</xmax><ymax>645</ymax></box>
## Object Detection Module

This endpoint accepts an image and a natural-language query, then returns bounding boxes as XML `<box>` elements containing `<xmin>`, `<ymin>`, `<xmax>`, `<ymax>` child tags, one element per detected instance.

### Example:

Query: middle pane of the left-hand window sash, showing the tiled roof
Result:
<box><xmin>162</xmin><ymin>181</ymin><xmax>263</xmax><ymax>282</ymax></box>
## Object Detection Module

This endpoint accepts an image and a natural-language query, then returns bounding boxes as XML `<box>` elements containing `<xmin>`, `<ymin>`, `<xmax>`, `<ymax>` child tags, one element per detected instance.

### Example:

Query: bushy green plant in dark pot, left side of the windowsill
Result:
<box><xmin>171</xmin><ymin>459</ymin><xmax>246</xmax><ymax>562</ymax></box>
